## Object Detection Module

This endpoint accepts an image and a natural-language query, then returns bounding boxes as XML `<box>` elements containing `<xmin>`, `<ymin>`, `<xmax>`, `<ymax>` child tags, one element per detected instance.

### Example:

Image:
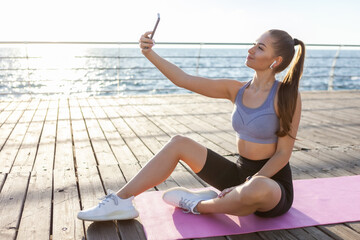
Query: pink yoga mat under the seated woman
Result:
<box><xmin>135</xmin><ymin>175</ymin><xmax>360</xmax><ymax>240</ymax></box>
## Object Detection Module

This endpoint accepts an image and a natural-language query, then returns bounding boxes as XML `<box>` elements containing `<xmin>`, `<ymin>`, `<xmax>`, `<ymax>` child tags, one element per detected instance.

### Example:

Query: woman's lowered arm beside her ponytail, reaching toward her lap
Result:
<box><xmin>254</xmin><ymin>93</ymin><xmax>301</xmax><ymax>178</ymax></box>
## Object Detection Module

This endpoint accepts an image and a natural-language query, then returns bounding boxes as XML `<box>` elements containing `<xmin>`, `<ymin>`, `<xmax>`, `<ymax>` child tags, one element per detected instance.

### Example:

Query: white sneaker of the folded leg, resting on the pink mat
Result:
<box><xmin>163</xmin><ymin>187</ymin><xmax>218</xmax><ymax>214</ymax></box>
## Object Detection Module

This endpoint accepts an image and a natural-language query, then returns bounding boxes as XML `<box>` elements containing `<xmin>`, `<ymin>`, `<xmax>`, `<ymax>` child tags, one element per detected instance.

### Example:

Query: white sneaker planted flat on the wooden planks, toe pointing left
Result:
<box><xmin>77</xmin><ymin>193</ymin><xmax>139</xmax><ymax>221</ymax></box>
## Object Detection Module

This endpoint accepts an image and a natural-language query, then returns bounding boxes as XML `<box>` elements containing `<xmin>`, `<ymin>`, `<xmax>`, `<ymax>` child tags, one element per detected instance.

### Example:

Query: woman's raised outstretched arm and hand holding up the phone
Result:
<box><xmin>139</xmin><ymin>32</ymin><xmax>243</xmax><ymax>102</ymax></box>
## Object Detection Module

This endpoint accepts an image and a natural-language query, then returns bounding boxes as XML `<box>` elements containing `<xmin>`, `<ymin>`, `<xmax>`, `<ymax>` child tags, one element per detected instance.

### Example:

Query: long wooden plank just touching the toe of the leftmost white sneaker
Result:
<box><xmin>52</xmin><ymin>99</ymin><xmax>85</xmax><ymax>240</ymax></box>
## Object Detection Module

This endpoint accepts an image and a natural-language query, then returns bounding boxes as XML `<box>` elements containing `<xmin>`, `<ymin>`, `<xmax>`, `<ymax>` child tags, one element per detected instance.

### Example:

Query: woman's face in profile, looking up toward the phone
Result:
<box><xmin>245</xmin><ymin>32</ymin><xmax>275</xmax><ymax>71</ymax></box>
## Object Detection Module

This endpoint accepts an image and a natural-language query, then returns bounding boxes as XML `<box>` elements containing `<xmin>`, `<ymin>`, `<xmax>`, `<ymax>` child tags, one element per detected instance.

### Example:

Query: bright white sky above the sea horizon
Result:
<box><xmin>0</xmin><ymin>0</ymin><xmax>360</xmax><ymax>44</ymax></box>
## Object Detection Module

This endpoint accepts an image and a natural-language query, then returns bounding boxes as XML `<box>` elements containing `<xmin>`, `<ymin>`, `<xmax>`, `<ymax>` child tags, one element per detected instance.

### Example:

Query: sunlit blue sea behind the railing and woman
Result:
<box><xmin>0</xmin><ymin>44</ymin><xmax>360</xmax><ymax>98</ymax></box>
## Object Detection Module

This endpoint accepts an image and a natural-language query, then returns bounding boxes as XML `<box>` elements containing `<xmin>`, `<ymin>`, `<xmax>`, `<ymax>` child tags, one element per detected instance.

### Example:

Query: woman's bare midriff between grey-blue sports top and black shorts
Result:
<box><xmin>236</xmin><ymin>139</ymin><xmax>277</xmax><ymax>160</ymax></box>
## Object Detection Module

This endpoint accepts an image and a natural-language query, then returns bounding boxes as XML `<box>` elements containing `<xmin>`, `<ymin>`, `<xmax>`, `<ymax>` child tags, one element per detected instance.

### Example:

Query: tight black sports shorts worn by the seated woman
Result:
<box><xmin>197</xmin><ymin>149</ymin><xmax>294</xmax><ymax>217</ymax></box>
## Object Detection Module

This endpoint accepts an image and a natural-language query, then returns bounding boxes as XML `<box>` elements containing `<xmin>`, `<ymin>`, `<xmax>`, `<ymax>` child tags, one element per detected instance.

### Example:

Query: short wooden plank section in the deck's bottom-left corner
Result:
<box><xmin>0</xmin><ymin>173</ymin><xmax>29</xmax><ymax>239</ymax></box>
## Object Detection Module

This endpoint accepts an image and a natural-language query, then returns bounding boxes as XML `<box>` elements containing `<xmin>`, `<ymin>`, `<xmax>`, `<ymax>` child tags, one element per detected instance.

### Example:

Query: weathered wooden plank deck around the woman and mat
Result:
<box><xmin>0</xmin><ymin>91</ymin><xmax>360</xmax><ymax>240</ymax></box>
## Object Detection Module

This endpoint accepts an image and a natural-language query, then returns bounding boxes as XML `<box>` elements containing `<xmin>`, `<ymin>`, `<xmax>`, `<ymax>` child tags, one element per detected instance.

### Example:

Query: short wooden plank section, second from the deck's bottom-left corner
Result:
<box><xmin>16</xmin><ymin>171</ymin><xmax>52</xmax><ymax>240</ymax></box>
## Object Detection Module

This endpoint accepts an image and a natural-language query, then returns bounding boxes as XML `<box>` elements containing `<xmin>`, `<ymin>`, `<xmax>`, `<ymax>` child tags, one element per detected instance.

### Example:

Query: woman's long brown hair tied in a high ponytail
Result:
<box><xmin>268</xmin><ymin>29</ymin><xmax>305</xmax><ymax>138</ymax></box>
